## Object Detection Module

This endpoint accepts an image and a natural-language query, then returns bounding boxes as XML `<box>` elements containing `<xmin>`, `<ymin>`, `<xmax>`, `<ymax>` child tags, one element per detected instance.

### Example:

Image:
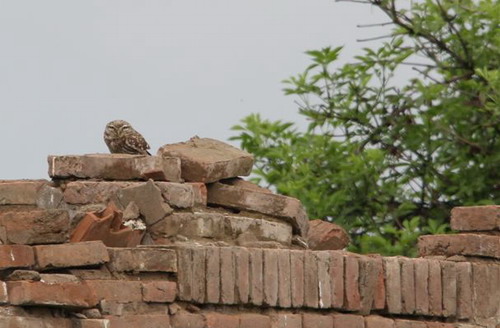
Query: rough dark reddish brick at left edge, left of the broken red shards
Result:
<box><xmin>0</xmin><ymin>209</ymin><xmax>69</xmax><ymax>245</ymax></box>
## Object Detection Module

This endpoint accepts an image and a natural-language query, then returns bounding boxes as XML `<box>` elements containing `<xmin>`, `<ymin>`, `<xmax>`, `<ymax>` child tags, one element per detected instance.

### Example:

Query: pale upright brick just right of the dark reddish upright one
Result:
<box><xmin>384</xmin><ymin>257</ymin><xmax>402</xmax><ymax>314</ymax></box>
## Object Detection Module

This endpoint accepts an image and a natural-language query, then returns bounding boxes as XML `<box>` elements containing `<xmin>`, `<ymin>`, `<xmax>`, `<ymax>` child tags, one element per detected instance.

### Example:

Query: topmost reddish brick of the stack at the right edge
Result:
<box><xmin>451</xmin><ymin>205</ymin><xmax>500</xmax><ymax>231</ymax></box>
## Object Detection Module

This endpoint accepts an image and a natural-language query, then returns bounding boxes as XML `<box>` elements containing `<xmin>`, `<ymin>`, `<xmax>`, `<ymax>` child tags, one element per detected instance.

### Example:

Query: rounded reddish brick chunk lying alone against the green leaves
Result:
<box><xmin>307</xmin><ymin>220</ymin><xmax>350</xmax><ymax>250</ymax></box>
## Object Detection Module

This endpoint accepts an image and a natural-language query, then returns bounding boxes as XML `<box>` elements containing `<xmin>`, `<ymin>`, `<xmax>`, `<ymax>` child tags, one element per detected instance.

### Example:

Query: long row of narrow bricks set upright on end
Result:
<box><xmin>177</xmin><ymin>247</ymin><xmax>500</xmax><ymax>319</ymax></box>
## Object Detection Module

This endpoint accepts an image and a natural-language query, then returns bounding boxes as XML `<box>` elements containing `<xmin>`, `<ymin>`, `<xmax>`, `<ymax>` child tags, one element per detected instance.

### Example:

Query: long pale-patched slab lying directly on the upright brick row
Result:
<box><xmin>150</xmin><ymin>212</ymin><xmax>292</xmax><ymax>245</ymax></box>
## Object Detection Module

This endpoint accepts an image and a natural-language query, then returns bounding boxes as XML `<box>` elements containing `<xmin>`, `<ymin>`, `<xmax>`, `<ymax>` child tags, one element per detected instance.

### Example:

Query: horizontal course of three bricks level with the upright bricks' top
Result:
<box><xmin>0</xmin><ymin>241</ymin><xmax>177</xmax><ymax>272</ymax></box>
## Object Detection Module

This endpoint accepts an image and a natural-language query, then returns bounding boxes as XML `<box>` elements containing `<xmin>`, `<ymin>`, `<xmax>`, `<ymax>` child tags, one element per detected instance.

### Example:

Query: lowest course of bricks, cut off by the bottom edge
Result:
<box><xmin>0</xmin><ymin>312</ymin><xmax>486</xmax><ymax>328</ymax></box>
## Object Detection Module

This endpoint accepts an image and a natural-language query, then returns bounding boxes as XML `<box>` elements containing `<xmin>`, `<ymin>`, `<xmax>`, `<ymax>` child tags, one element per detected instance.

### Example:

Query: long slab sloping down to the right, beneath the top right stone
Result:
<box><xmin>208</xmin><ymin>182</ymin><xmax>309</xmax><ymax>237</ymax></box>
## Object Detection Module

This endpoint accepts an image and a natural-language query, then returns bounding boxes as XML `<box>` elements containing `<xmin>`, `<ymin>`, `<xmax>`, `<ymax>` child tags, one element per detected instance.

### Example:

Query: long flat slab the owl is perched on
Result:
<box><xmin>47</xmin><ymin>154</ymin><xmax>181</xmax><ymax>182</ymax></box>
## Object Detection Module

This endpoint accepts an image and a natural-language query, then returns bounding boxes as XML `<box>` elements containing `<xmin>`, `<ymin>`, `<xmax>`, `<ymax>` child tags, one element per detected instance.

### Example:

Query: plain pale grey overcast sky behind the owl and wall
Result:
<box><xmin>0</xmin><ymin>0</ymin><xmax>387</xmax><ymax>179</ymax></box>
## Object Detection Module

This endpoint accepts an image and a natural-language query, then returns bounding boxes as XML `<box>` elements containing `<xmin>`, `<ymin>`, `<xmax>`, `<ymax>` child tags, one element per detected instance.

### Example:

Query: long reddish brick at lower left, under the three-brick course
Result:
<box><xmin>7</xmin><ymin>281</ymin><xmax>98</xmax><ymax>308</ymax></box>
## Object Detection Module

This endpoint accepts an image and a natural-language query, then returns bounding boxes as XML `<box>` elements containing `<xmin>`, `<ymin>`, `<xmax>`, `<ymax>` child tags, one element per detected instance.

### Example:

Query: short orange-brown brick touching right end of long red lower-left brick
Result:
<box><xmin>86</xmin><ymin>280</ymin><xmax>142</xmax><ymax>303</ymax></box>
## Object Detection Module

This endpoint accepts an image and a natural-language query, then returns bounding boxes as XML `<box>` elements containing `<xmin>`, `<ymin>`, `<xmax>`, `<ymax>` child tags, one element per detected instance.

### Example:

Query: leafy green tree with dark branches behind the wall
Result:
<box><xmin>232</xmin><ymin>0</ymin><xmax>500</xmax><ymax>256</ymax></box>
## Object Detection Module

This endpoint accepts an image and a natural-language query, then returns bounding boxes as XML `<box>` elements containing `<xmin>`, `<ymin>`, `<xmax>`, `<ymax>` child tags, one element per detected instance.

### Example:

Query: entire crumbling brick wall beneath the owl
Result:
<box><xmin>0</xmin><ymin>138</ymin><xmax>500</xmax><ymax>328</ymax></box>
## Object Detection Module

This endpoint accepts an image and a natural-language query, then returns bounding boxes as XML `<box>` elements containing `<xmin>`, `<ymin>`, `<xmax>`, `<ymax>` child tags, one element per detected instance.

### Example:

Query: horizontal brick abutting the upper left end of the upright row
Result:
<box><xmin>108</xmin><ymin>247</ymin><xmax>177</xmax><ymax>272</ymax></box>
